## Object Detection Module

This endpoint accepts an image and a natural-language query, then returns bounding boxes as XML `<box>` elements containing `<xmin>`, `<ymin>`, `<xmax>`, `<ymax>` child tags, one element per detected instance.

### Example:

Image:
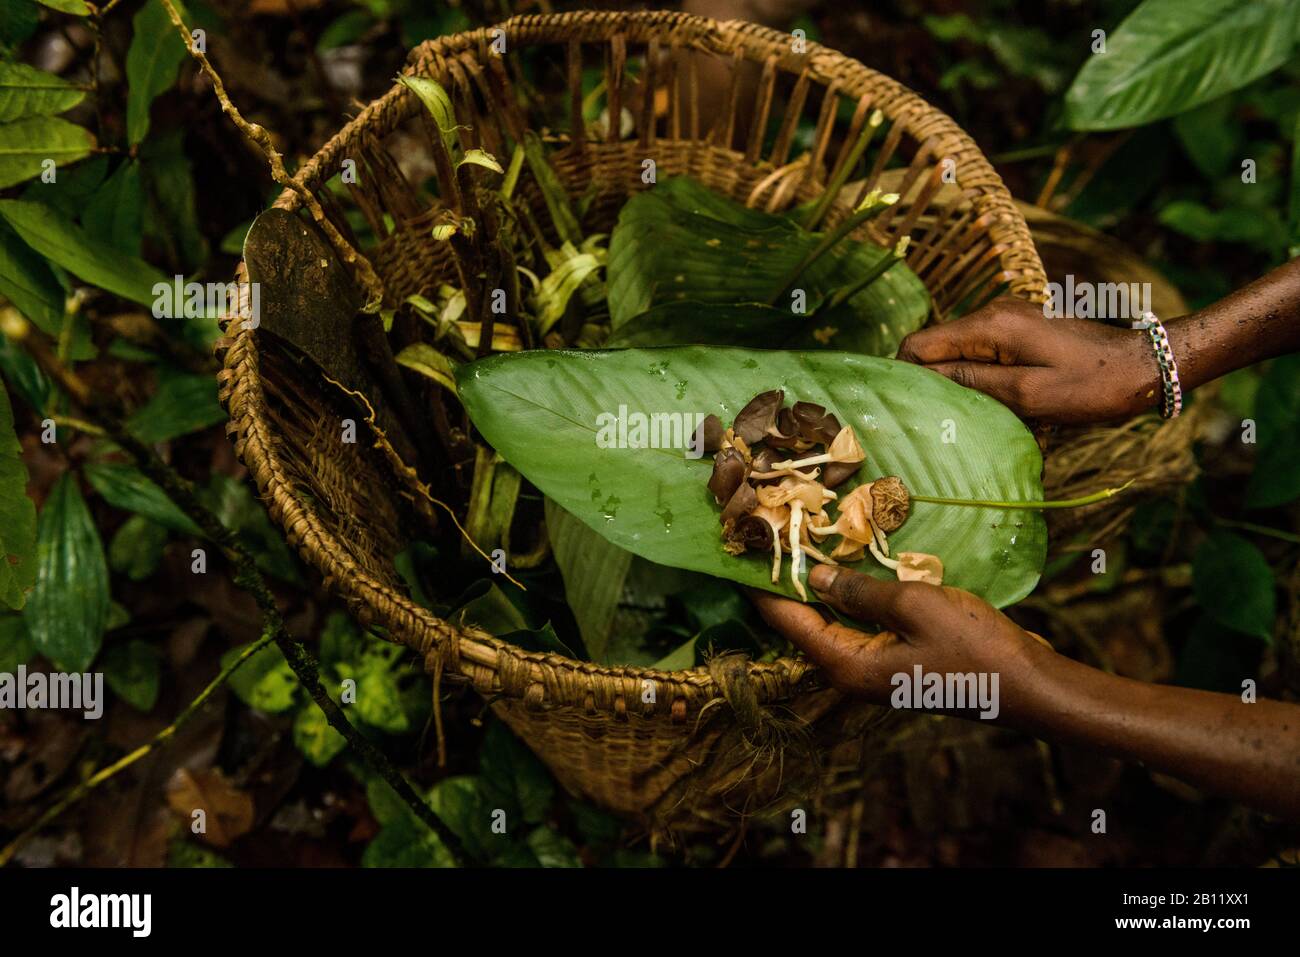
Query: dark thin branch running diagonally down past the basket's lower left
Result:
<box><xmin>5</xmin><ymin>320</ymin><xmax>467</xmax><ymax>865</ymax></box>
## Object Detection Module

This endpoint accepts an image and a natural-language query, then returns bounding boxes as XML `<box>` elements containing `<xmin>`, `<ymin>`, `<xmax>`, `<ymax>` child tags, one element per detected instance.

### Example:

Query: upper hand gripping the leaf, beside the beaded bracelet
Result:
<box><xmin>898</xmin><ymin>298</ymin><xmax>1160</xmax><ymax>424</ymax></box>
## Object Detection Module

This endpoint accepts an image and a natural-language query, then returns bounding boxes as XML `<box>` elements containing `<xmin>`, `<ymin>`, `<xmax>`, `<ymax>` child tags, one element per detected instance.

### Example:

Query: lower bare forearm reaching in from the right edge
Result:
<box><xmin>1006</xmin><ymin>649</ymin><xmax>1300</xmax><ymax>818</ymax></box>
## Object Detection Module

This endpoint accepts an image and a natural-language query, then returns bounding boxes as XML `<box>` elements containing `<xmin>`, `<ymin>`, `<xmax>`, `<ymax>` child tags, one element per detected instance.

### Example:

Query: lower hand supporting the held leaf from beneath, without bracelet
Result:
<box><xmin>754</xmin><ymin>564</ymin><xmax>1054</xmax><ymax>714</ymax></box>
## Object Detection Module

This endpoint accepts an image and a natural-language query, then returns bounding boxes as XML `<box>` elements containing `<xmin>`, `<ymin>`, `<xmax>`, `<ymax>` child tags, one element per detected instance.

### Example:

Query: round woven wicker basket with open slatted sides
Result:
<box><xmin>218</xmin><ymin>13</ymin><xmax>1045</xmax><ymax>827</ymax></box>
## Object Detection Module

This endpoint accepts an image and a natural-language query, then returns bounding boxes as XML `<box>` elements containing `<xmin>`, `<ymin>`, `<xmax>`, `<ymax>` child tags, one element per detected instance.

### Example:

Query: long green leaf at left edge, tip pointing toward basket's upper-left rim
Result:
<box><xmin>0</xmin><ymin>199</ymin><xmax>168</xmax><ymax>306</ymax></box>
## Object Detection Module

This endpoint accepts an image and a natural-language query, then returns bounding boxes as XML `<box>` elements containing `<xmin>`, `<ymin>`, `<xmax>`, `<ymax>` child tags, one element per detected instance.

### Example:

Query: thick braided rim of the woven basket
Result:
<box><xmin>216</xmin><ymin>10</ymin><xmax>1047</xmax><ymax>723</ymax></box>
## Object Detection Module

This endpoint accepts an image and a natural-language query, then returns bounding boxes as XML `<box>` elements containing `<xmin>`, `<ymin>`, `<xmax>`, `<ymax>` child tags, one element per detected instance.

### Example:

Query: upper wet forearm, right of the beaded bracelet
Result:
<box><xmin>1165</xmin><ymin>260</ymin><xmax>1300</xmax><ymax>390</ymax></box>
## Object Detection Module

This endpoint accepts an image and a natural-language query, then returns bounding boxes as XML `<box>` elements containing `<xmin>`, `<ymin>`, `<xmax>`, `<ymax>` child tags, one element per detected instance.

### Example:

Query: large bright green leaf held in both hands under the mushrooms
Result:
<box><xmin>458</xmin><ymin>347</ymin><xmax>1047</xmax><ymax>606</ymax></box>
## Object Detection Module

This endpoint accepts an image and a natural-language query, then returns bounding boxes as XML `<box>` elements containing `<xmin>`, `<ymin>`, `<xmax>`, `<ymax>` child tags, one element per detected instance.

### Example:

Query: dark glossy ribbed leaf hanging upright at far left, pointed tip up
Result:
<box><xmin>23</xmin><ymin>472</ymin><xmax>109</xmax><ymax>671</ymax></box>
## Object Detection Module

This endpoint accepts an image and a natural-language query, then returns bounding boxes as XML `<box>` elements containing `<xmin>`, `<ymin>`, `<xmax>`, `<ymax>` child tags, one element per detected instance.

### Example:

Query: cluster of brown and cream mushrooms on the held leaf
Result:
<box><xmin>701</xmin><ymin>389</ymin><xmax>944</xmax><ymax>601</ymax></box>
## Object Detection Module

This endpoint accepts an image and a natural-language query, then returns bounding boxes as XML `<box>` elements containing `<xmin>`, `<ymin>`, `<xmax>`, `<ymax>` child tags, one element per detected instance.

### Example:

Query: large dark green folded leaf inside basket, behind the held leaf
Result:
<box><xmin>607</xmin><ymin>177</ymin><xmax>930</xmax><ymax>355</ymax></box>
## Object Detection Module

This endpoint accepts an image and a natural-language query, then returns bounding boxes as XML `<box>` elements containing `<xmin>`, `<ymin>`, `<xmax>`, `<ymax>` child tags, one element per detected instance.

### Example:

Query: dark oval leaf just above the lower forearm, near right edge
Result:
<box><xmin>1192</xmin><ymin>532</ymin><xmax>1277</xmax><ymax>644</ymax></box>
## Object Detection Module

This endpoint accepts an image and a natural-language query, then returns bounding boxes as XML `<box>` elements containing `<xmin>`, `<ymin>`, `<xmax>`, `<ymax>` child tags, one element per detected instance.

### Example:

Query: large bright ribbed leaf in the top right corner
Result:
<box><xmin>1065</xmin><ymin>0</ymin><xmax>1300</xmax><ymax>130</ymax></box>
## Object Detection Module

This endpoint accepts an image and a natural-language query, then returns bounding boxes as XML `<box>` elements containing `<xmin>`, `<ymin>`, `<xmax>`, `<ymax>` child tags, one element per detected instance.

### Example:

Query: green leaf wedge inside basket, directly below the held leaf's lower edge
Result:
<box><xmin>546</xmin><ymin>498</ymin><xmax>633</xmax><ymax>662</ymax></box>
